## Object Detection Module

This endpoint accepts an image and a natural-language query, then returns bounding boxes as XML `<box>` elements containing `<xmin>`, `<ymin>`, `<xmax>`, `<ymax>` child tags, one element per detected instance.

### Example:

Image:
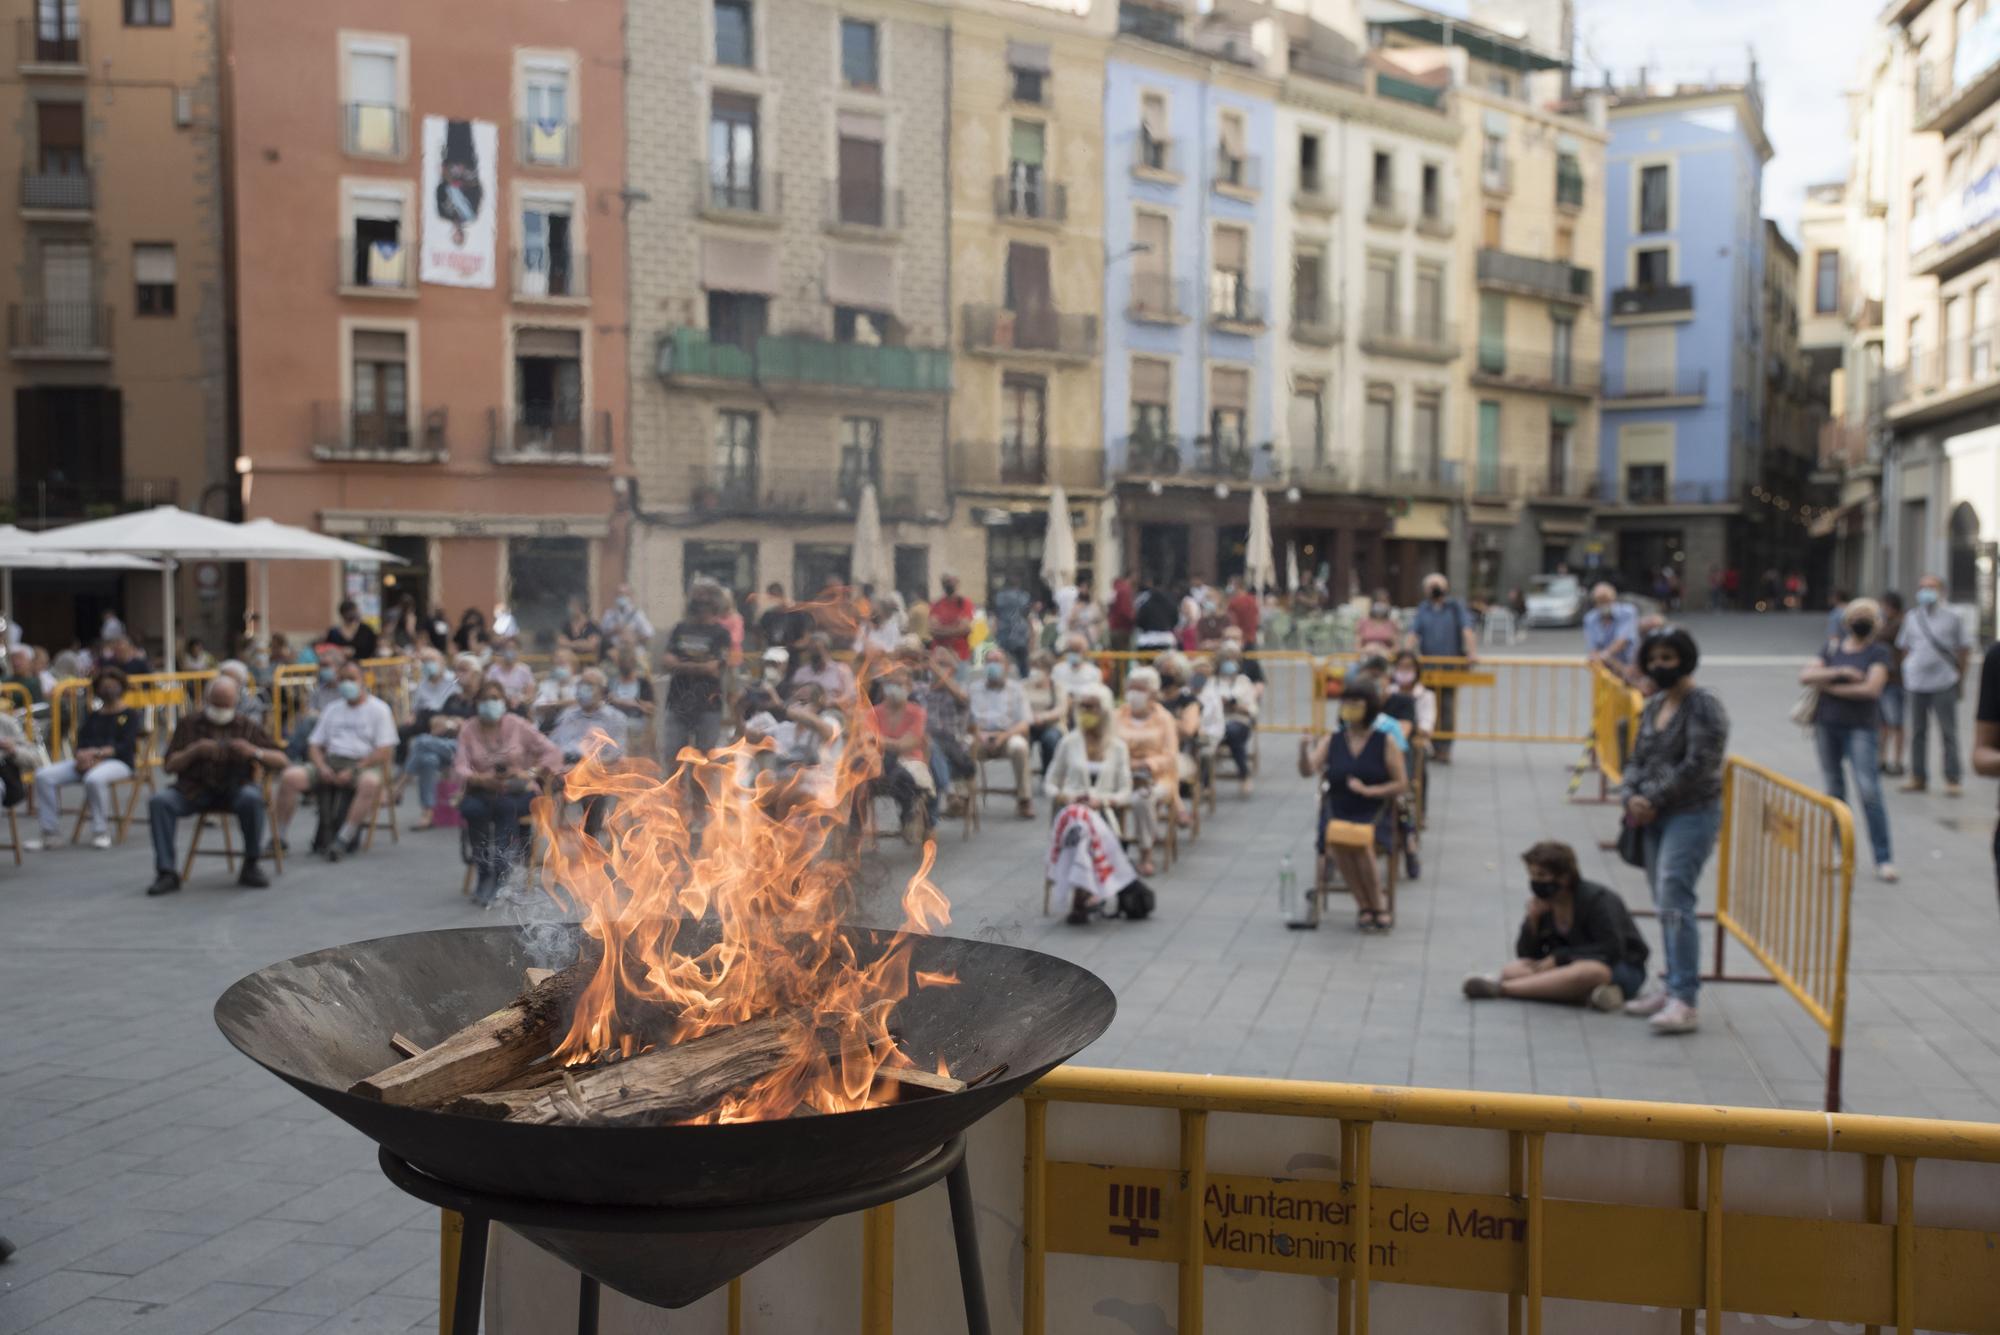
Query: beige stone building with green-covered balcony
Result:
<box><xmin>628</xmin><ymin>0</ymin><xmax>952</xmax><ymax>606</ymax></box>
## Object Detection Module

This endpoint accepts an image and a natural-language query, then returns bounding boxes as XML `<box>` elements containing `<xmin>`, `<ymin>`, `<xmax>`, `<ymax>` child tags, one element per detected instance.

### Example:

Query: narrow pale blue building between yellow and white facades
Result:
<box><xmin>1102</xmin><ymin>0</ymin><xmax>1282</xmax><ymax>584</ymax></box>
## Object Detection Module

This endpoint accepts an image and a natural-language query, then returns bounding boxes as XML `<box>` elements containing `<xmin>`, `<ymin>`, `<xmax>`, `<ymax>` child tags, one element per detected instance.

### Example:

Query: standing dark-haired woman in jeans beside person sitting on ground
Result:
<box><xmin>1624</xmin><ymin>628</ymin><xmax>1730</xmax><ymax>1033</ymax></box>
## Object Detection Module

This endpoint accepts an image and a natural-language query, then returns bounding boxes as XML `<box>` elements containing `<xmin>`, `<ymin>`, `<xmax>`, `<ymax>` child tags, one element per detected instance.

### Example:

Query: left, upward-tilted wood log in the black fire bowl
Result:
<box><xmin>348</xmin><ymin>955</ymin><xmax>598</xmax><ymax>1107</ymax></box>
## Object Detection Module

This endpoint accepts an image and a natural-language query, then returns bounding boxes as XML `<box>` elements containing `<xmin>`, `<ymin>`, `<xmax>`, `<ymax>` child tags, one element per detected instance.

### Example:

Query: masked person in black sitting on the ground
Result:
<box><xmin>1464</xmin><ymin>839</ymin><xmax>1646</xmax><ymax>1011</ymax></box>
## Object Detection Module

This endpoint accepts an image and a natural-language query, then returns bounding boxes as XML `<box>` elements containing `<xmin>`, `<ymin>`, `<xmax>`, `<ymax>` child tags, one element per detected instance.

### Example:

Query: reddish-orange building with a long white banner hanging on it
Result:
<box><xmin>224</xmin><ymin>0</ymin><xmax>630</xmax><ymax>642</ymax></box>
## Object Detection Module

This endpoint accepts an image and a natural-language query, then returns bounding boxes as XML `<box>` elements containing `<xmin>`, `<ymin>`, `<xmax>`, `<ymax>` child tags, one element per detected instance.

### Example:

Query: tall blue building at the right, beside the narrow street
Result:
<box><xmin>1598</xmin><ymin>84</ymin><xmax>1770</xmax><ymax>590</ymax></box>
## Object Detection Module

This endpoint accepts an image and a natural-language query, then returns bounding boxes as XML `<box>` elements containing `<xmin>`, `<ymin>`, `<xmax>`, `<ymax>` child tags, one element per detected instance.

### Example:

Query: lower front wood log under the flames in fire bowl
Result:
<box><xmin>444</xmin><ymin>1019</ymin><xmax>798</xmax><ymax>1125</ymax></box>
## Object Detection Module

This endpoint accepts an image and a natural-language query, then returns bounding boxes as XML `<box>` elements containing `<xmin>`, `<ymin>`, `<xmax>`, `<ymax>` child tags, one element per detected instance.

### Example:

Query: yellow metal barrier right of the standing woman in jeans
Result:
<box><xmin>1714</xmin><ymin>755</ymin><xmax>1854</xmax><ymax>1113</ymax></box>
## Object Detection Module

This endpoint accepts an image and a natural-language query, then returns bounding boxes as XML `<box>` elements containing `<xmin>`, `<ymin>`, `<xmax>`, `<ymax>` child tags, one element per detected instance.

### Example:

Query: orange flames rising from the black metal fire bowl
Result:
<box><xmin>536</xmin><ymin>651</ymin><xmax>958</xmax><ymax>1121</ymax></box>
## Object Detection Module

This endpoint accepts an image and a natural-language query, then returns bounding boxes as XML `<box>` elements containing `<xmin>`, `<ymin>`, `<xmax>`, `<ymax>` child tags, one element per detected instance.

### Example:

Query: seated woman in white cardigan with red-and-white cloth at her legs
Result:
<box><xmin>1046</xmin><ymin>685</ymin><xmax>1138</xmax><ymax>923</ymax></box>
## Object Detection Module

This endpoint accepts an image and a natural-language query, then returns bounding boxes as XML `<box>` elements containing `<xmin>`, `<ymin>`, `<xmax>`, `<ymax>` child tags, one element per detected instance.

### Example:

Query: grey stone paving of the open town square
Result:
<box><xmin>0</xmin><ymin>618</ymin><xmax>2000</xmax><ymax>1335</ymax></box>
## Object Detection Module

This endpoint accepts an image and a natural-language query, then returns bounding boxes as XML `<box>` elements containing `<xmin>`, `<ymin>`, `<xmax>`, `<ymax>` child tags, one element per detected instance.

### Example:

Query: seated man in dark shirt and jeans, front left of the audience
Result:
<box><xmin>146</xmin><ymin>671</ymin><xmax>284</xmax><ymax>895</ymax></box>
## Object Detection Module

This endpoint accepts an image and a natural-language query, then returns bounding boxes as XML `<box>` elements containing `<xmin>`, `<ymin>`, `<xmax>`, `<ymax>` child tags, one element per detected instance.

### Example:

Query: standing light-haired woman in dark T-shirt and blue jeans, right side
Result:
<box><xmin>1798</xmin><ymin>598</ymin><xmax>1896</xmax><ymax>881</ymax></box>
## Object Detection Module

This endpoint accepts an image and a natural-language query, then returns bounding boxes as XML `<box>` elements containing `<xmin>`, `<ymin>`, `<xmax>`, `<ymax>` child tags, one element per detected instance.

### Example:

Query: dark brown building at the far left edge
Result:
<box><xmin>0</xmin><ymin>0</ymin><xmax>234</xmax><ymax>646</ymax></box>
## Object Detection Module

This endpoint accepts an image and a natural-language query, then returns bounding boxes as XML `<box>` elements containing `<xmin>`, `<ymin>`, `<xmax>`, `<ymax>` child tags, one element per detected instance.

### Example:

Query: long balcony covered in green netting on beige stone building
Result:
<box><xmin>656</xmin><ymin>328</ymin><xmax>952</xmax><ymax>396</ymax></box>
